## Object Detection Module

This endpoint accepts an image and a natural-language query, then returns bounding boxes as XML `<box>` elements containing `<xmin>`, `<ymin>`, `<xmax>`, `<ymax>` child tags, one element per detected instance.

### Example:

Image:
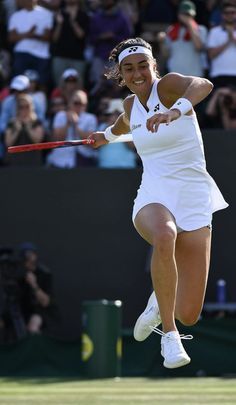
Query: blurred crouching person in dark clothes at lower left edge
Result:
<box><xmin>0</xmin><ymin>242</ymin><xmax>56</xmax><ymax>344</ymax></box>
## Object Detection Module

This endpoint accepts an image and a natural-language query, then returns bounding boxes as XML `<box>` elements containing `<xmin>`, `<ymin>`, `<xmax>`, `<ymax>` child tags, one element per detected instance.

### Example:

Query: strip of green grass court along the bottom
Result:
<box><xmin>0</xmin><ymin>378</ymin><xmax>236</xmax><ymax>405</ymax></box>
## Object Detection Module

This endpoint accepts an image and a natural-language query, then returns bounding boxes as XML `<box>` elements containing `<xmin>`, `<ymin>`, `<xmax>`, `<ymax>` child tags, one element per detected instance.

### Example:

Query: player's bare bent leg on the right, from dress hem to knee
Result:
<box><xmin>175</xmin><ymin>227</ymin><xmax>211</xmax><ymax>325</ymax></box>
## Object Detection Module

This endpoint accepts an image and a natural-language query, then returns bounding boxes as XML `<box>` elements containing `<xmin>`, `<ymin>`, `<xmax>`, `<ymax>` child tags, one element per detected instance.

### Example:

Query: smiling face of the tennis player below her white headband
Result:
<box><xmin>120</xmin><ymin>54</ymin><xmax>156</xmax><ymax>95</ymax></box>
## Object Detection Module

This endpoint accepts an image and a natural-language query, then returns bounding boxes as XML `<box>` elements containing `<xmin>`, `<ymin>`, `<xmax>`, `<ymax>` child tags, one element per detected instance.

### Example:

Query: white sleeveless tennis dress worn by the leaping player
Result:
<box><xmin>130</xmin><ymin>79</ymin><xmax>228</xmax><ymax>231</ymax></box>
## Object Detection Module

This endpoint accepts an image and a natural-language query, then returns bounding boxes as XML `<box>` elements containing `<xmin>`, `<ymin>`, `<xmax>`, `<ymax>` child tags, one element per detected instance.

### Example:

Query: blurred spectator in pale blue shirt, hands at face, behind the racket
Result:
<box><xmin>47</xmin><ymin>90</ymin><xmax>97</xmax><ymax>168</ymax></box>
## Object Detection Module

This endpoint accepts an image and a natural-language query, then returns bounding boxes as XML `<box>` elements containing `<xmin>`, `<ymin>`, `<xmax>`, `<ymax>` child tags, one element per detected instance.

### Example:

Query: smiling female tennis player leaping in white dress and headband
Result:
<box><xmin>88</xmin><ymin>38</ymin><xmax>228</xmax><ymax>368</ymax></box>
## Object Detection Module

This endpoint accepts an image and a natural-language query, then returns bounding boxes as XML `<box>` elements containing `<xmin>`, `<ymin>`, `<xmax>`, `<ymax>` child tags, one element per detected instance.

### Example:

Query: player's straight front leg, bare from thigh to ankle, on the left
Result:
<box><xmin>135</xmin><ymin>204</ymin><xmax>177</xmax><ymax>333</ymax></box>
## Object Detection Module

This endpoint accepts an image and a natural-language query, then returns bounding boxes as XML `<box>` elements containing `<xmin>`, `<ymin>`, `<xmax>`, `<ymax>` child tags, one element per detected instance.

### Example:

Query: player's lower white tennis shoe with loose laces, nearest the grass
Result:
<box><xmin>153</xmin><ymin>328</ymin><xmax>193</xmax><ymax>368</ymax></box>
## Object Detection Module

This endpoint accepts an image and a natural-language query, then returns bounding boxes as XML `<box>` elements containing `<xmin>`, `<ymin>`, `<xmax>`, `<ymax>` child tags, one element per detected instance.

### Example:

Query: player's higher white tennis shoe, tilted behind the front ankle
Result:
<box><xmin>133</xmin><ymin>291</ymin><xmax>161</xmax><ymax>342</ymax></box>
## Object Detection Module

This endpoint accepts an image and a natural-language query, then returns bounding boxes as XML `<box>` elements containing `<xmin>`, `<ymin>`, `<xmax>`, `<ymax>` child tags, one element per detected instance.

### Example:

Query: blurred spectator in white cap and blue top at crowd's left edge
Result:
<box><xmin>0</xmin><ymin>75</ymin><xmax>45</xmax><ymax>133</ymax></box>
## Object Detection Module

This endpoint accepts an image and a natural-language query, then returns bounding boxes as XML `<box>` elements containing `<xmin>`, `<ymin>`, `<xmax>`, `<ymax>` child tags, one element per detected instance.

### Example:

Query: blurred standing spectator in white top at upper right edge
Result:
<box><xmin>208</xmin><ymin>2</ymin><xmax>236</xmax><ymax>88</ymax></box>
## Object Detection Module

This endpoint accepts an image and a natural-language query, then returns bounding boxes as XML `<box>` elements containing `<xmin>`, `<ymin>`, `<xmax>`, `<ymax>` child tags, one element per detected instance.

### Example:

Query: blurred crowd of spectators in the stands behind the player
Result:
<box><xmin>0</xmin><ymin>0</ymin><xmax>236</xmax><ymax>168</ymax></box>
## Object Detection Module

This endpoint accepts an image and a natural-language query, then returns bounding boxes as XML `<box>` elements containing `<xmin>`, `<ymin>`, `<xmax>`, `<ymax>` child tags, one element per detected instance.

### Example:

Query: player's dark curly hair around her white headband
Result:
<box><xmin>105</xmin><ymin>37</ymin><xmax>159</xmax><ymax>86</ymax></box>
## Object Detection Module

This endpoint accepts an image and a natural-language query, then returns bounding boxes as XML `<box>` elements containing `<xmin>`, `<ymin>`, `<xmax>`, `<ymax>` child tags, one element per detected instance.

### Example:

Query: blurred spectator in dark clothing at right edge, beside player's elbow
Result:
<box><xmin>206</xmin><ymin>87</ymin><xmax>236</xmax><ymax>129</ymax></box>
